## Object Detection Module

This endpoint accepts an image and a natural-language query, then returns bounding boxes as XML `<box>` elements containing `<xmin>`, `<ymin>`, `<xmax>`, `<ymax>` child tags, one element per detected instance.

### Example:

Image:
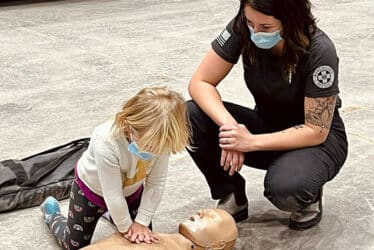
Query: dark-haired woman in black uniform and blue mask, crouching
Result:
<box><xmin>188</xmin><ymin>0</ymin><xmax>348</xmax><ymax>230</ymax></box>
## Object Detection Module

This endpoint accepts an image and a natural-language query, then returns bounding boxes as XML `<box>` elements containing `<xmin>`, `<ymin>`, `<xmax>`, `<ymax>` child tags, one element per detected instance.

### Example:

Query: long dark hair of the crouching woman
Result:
<box><xmin>234</xmin><ymin>0</ymin><xmax>317</xmax><ymax>77</ymax></box>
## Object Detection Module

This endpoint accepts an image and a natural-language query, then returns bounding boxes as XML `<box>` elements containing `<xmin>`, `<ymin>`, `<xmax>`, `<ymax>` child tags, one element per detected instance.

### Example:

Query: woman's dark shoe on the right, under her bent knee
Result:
<box><xmin>289</xmin><ymin>190</ymin><xmax>322</xmax><ymax>230</ymax></box>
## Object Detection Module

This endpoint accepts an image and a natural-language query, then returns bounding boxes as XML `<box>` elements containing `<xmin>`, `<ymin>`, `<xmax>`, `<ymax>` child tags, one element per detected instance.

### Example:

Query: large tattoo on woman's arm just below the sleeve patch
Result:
<box><xmin>304</xmin><ymin>96</ymin><xmax>336</xmax><ymax>133</ymax></box>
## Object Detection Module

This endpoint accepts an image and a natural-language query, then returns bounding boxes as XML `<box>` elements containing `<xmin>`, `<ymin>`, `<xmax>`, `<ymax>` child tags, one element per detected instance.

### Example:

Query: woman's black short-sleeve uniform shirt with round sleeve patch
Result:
<box><xmin>212</xmin><ymin>20</ymin><xmax>340</xmax><ymax>129</ymax></box>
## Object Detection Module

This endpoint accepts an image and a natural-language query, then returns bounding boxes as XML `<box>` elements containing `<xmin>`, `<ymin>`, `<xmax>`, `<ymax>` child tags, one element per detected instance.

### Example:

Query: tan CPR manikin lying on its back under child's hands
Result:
<box><xmin>84</xmin><ymin>209</ymin><xmax>238</xmax><ymax>250</ymax></box>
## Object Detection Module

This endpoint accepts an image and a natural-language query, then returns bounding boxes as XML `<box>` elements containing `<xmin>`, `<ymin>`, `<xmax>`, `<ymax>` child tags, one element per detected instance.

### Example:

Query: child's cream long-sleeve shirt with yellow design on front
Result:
<box><xmin>77</xmin><ymin>120</ymin><xmax>169</xmax><ymax>233</ymax></box>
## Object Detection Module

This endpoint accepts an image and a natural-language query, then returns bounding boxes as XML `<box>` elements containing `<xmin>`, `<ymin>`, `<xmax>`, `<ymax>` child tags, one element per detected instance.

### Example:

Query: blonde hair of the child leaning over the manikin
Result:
<box><xmin>113</xmin><ymin>87</ymin><xmax>190</xmax><ymax>155</ymax></box>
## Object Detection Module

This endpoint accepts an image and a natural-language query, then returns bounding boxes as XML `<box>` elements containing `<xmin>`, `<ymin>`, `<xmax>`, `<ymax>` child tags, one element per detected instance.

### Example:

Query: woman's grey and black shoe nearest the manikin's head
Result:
<box><xmin>217</xmin><ymin>193</ymin><xmax>248</xmax><ymax>222</ymax></box>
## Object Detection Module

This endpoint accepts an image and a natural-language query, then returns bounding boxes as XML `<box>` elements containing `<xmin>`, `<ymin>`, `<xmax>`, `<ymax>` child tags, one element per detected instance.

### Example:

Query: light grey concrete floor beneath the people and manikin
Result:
<box><xmin>0</xmin><ymin>0</ymin><xmax>374</xmax><ymax>249</ymax></box>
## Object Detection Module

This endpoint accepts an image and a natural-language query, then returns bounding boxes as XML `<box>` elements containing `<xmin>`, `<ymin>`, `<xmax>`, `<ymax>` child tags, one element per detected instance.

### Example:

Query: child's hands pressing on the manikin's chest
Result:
<box><xmin>123</xmin><ymin>222</ymin><xmax>160</xmax><ymax>244</ymax></box>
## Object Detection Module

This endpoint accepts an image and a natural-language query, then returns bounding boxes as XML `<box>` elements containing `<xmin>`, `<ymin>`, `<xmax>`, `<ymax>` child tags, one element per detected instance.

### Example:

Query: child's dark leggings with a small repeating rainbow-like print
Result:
<box><xmin>48</xmin><ymin>181</ymin><xmax>141</xmax><ymax>250</ymax></box>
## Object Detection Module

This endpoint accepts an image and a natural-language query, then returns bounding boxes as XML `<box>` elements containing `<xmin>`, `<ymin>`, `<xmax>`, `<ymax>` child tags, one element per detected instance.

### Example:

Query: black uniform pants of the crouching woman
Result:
<box><xmin>187</xmin><ymin>101</ymin><xmax>348</xmax><ymax>211</ymax></box>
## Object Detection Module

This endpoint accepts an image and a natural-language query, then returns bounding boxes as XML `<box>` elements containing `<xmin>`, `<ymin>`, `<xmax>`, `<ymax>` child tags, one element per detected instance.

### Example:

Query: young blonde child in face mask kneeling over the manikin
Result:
<box><xmin>41</xmin><ymin>87</ymin><xmax>190</xmax><ymax>249</ymax></box>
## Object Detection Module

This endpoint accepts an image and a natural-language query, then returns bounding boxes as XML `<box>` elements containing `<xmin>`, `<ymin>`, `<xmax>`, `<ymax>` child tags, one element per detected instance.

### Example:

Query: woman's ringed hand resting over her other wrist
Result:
<box><xmin>219</xmin><ymin>124</ymin><xmax>255</xmax><ymax>152</ymax></box>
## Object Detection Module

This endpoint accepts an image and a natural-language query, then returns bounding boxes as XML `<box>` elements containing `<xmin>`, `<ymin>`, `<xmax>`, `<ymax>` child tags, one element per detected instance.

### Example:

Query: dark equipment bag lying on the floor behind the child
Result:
<box><xmin>0</xmin><ymin>138</ymin><xmax>90</xmax><ymax>212</ymax></box>
